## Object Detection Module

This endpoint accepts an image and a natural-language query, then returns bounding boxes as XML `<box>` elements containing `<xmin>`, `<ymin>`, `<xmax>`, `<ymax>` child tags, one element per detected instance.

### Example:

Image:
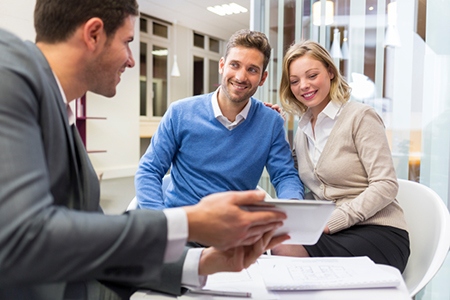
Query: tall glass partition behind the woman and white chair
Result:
<box><xmin>252</xmin><ymin>0</ymin><xmax>450</xmax><ymax>299</ymax></box>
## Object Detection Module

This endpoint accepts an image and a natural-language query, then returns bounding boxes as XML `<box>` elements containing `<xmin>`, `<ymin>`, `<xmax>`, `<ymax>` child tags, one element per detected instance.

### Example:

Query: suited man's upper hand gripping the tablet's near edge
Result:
<box><xmin>184</xmin><ymin>190</ymin><xmax>286</xmax><ymax>250</ymax></box>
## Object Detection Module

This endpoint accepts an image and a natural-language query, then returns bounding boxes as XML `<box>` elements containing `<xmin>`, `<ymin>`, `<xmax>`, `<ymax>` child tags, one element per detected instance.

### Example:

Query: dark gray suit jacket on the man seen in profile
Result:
<box><xmin>0</xmin><ymin>30</ymin><xmax>184</xmax><ymax>299</ymax></box>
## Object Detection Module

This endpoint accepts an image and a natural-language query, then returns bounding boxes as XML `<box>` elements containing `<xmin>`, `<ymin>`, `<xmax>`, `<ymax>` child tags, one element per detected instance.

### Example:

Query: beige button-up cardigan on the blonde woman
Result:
<box><xmin>294</xmin><ymin>102</ymin><xmax>407</xmax><ymax>234</ymax></box>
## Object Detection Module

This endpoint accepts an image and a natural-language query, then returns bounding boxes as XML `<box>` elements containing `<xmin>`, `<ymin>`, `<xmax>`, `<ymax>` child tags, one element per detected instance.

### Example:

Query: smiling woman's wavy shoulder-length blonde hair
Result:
<box><xmin>280</xmin><ymin>40</ymin><xmax>351</xmax><ymax>115</ymax></box>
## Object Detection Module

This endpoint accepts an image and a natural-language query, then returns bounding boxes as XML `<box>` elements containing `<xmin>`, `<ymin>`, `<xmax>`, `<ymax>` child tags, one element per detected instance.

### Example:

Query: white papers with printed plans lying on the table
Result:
<box><xmin>178</xmin><ymin>256</ymin><xmax>401</xmax><ymax>300</ymax></box>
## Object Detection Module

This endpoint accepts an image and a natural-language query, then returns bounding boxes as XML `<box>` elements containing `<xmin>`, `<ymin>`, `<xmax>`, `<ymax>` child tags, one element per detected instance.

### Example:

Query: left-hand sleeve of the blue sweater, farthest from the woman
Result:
<box><xmin>135</xmin><ymin>105</ymin><xmax>178</xmax><ymax>209</ymax></box>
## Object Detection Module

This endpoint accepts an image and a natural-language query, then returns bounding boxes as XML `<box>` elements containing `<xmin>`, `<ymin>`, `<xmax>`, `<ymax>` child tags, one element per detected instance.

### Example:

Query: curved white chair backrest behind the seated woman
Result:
<box><xmin>397</xmin><ymin>179</ymin><xmax>450</xmax><ymax>297</ymax></box>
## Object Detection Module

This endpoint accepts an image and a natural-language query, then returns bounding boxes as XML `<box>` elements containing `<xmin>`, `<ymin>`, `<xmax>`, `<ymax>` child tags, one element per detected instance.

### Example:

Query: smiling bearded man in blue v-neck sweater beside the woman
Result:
<box><xmin>135</xmin><ymin>30</ymin><xmax>304</xmax><ymax>209</ymax></box>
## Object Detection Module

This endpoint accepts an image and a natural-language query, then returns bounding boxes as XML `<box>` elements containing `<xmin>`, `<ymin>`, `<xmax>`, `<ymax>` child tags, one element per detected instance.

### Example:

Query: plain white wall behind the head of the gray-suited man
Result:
<box><xmin>0</xmin><ymin>0</ymin><xmax>140</xmax><ymax>179</ymax></box>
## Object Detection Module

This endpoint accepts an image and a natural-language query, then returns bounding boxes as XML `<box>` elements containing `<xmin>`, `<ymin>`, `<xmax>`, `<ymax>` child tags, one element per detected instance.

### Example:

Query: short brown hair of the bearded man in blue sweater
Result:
<box><xmin>225</xmin><ymin>29</ymin><xmax>272</xmax><ymax>71</ymax></box>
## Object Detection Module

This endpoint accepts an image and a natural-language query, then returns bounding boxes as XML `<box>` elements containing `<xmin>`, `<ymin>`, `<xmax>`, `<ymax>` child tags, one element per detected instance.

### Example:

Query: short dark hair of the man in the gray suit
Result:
<box><xmin>34</xmin><ymin>0</ymin><xmax>139</xmax><ymax>43</ymax></box>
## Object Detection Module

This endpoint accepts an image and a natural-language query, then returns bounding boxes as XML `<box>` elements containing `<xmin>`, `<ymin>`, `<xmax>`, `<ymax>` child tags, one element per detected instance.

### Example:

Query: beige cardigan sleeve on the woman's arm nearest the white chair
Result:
<box><xmin>328</xmin><ymin>108</ymin><xmax>398</xmax><ymax>233</ymax></box>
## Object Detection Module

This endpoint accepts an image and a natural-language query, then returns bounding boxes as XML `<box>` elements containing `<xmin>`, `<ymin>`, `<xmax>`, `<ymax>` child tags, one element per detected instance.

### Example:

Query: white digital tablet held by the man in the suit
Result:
<box><xmin>243</xmin><ymin>199</ymin><xmax>335</xmax><ymax>245</ymax></box>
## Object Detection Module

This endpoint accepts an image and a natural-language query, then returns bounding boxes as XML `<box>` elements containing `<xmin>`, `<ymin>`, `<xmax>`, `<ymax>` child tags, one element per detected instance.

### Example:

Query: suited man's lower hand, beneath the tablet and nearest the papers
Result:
<box><xmin>198</xmin><ymin>230</ymin><xmax>289</xmax><ymax>275</ymax></box>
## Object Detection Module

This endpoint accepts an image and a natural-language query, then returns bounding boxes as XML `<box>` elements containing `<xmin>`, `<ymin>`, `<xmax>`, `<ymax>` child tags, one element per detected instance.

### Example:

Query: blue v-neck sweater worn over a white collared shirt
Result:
<box><xmin>135</xmin><ymin>93</ymin><xmax>303</xmax><ymax>209</ymax></box>
